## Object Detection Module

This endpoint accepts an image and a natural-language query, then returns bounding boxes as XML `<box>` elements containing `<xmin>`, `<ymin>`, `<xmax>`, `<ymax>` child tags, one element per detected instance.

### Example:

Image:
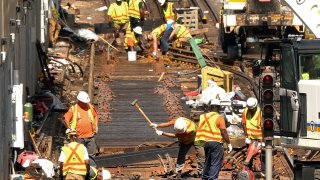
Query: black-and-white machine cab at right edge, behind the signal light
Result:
<box><xmin>279</xmin><ymin>39</ymin><xmax>320</xmax><ymax>149</ymax></box>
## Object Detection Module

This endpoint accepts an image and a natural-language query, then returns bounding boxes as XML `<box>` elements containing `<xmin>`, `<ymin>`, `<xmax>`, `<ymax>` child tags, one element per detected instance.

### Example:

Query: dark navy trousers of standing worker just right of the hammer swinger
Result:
<box><xmin>202</xmin><ymin>141</ymin><xmax>224</xmax><ymax>180</ymax></box>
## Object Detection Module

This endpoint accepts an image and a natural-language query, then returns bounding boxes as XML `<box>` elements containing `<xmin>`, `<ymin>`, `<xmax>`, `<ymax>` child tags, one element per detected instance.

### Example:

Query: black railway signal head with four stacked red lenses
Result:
<box><xmin>261</xmin><ymin>69</ymin><xmax>274</xmax><ymax>138</ymax></box>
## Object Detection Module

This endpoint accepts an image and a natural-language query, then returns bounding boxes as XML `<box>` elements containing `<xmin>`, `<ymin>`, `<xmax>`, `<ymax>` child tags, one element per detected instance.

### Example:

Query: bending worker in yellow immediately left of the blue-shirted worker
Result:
<box><xmin>145</xmin><ymin>24</ymin><xmax>167</xmax><ymax>57</ymax></box>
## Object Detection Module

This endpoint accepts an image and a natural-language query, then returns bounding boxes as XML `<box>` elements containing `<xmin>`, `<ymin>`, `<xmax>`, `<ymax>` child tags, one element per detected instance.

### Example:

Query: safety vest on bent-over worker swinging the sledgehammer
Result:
<box><xmin>176</xmin><ymin>118</ymin><xmax>197</xmax><ymax>144</ymax></box>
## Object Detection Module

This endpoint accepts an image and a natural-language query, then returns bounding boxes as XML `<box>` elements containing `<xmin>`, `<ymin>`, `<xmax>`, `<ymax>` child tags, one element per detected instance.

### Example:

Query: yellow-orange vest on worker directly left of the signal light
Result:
<box><xmin>243</xmin><ymin>107</ymin><xmax>262</xmax><ymax>140</ymax></box>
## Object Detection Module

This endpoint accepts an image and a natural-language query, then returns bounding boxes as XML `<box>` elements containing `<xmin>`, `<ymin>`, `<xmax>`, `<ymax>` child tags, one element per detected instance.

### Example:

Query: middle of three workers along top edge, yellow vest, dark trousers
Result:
<box><xmin>128</xmin><ymin>0</ymin><xmax>149</xmax><ymax>30</ymax></box>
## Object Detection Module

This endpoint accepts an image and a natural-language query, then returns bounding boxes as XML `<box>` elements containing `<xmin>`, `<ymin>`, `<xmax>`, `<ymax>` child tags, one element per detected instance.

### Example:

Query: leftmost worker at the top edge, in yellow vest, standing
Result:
<box><xmin>107</xmin><ymin>0</ymin><xmax>129</xmax><ymax>45</ymax></box>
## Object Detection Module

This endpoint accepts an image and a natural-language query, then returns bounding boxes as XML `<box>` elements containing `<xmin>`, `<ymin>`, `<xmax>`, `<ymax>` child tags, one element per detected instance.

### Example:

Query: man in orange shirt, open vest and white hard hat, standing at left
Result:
<box><xmin>64</xmin><ymin>91</ymin><xmax>98</xmax><ymax>158</ymax></box>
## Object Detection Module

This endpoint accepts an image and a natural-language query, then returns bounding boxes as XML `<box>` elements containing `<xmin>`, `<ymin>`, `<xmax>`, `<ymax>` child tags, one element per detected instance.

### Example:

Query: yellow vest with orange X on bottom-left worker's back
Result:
<box><xmin>61</xmin><ymin>142</ymin><xmax>87</xmax><ymax>176</ymax></box>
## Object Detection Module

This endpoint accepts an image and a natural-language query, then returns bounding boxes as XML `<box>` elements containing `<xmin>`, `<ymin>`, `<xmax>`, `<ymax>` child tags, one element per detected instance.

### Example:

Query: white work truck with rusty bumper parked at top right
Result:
<box><xmin>219</xmin><ymin>0</ymin><xmax>305</xmax><ymax>57</ymax></box>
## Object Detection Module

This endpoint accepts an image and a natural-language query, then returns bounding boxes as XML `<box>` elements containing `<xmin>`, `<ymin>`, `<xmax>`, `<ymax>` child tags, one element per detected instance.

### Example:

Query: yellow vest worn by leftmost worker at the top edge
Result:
<box><xmin>108</xmin><ymin>2</ymin><xmax>129</xmax><ymax>24</ymax></box>
